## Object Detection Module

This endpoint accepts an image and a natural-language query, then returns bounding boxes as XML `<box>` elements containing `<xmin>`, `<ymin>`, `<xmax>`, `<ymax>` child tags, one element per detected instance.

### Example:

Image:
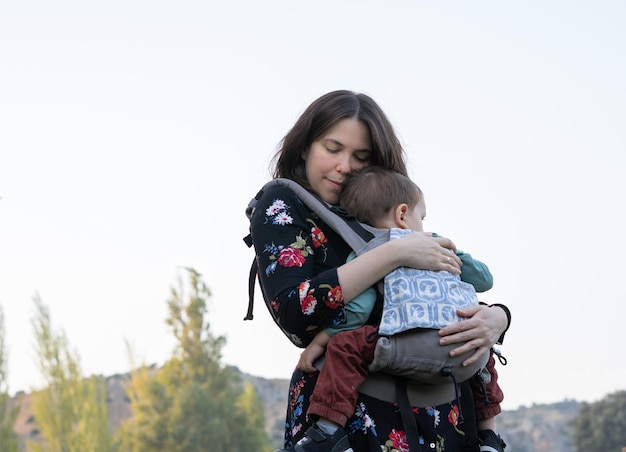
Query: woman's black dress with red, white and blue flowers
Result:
<box><xmin>251</xmin><ymin>186</ymin><xmax>464</xmax><ymax>452</ymax></box>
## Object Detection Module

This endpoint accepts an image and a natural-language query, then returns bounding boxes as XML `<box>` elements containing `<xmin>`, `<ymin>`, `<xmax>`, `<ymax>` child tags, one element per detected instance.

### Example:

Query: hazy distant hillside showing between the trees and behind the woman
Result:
<box><xmin>12</xmin><ymin>371</ymin><xmax>579</xmax><ymax>452</ymax></box>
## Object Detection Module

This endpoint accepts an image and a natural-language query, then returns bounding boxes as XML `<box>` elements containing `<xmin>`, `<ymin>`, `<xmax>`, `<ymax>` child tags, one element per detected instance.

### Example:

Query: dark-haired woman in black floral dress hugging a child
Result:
<box><xmin>251</xmin><ymin>91</ymin><xmax>508</xmax><ymax>452</ymax></box>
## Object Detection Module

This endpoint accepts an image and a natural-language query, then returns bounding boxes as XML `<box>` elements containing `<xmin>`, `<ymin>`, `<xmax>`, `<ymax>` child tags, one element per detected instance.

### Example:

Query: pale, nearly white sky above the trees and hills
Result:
<box><xmin>0</xmin><ymin>0</ymin><xmax>626</xmax><ymax>409</ymax></box>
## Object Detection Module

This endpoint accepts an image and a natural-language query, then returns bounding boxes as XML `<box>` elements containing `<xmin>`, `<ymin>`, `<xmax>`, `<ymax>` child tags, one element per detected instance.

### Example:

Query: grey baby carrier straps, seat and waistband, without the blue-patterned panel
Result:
<box><xmin>244</xmin><ymin>178</ymin><xmax>488</xmax><ymax>452</ymax></box>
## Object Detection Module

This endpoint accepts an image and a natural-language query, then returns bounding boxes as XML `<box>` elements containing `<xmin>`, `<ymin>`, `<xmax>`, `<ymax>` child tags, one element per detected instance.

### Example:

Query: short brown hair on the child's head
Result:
<box><xmin>340</xmin><ymin>166</ymin><xmax>423</xmax><ymax>226</ymax></box>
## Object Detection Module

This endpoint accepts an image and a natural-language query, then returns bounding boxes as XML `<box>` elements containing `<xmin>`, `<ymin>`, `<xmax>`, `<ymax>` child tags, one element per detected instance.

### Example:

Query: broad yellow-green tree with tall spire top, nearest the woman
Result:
<box><xmin>120</xmin><ymin>269</ymin><xmax>271</xmax><ymax>452</ymax></box>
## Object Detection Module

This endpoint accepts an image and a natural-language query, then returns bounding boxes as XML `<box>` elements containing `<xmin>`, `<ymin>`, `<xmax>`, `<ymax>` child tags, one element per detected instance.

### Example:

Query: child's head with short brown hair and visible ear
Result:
<box><xmin>340</xmin><ymin>166</ymin><xmax>426</xmax><ymax>231</ymax></box>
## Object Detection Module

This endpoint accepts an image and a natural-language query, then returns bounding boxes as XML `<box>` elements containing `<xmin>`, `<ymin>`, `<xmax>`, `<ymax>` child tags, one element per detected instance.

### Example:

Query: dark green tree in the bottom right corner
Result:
<box><xmin>571</xmin><ymin>391</ymin><xmax>626</xmax><ymax>452</ymax></box>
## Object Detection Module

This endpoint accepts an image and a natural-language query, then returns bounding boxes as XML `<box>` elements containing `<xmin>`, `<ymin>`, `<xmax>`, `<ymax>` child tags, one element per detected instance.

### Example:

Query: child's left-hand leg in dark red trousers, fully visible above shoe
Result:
<box><xmin>307</xmin><ymin>325</ymin><xmax>378</xmax><ymax>426</ymax></box>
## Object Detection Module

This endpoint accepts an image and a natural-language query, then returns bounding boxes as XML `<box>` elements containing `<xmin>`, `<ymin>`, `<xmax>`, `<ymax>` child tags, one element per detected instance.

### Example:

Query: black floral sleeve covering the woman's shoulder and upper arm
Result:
<box><xmin>250</xmin><ymin>186</ymin><xmax>350</xmax><ymax>347</ymax></box>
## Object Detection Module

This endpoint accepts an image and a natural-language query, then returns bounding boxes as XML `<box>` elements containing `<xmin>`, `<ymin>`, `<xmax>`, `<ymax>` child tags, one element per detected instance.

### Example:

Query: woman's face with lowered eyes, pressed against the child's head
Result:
<box><xmin>302</xmin><ymin>118</ymin><xmax>372</xmax><ymax>204</ymax></box>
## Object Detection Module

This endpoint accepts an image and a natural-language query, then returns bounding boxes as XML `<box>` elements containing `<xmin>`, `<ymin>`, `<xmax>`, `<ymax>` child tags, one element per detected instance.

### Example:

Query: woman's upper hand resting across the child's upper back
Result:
<box><xmin>392</xmin><ymin>232</ymin><xmax>463</xmax><ymax>275</ymax></box>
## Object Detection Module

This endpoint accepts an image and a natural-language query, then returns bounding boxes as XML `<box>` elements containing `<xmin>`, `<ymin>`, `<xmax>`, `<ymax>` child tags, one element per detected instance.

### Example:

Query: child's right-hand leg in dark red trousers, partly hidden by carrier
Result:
<box><xmin>471</xmin><ymin>352</ymin><xmax>504</xmax><ymax>431</ymax></box>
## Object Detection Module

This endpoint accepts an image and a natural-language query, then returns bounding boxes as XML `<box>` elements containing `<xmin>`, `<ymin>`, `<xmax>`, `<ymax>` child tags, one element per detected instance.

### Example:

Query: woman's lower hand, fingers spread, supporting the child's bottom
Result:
<box><xmin>439</xmin><ymin>305</ymin><xmax>508</xmax><ymax>366</ymax></box>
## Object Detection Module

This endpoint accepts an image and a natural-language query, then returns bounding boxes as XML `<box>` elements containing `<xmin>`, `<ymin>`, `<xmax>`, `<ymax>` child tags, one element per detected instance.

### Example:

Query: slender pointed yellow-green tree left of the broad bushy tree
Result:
<box><xmin>30</xmin><ymin>296</ymin><xmax>113</xmax><ymax>452</ymax></box>
